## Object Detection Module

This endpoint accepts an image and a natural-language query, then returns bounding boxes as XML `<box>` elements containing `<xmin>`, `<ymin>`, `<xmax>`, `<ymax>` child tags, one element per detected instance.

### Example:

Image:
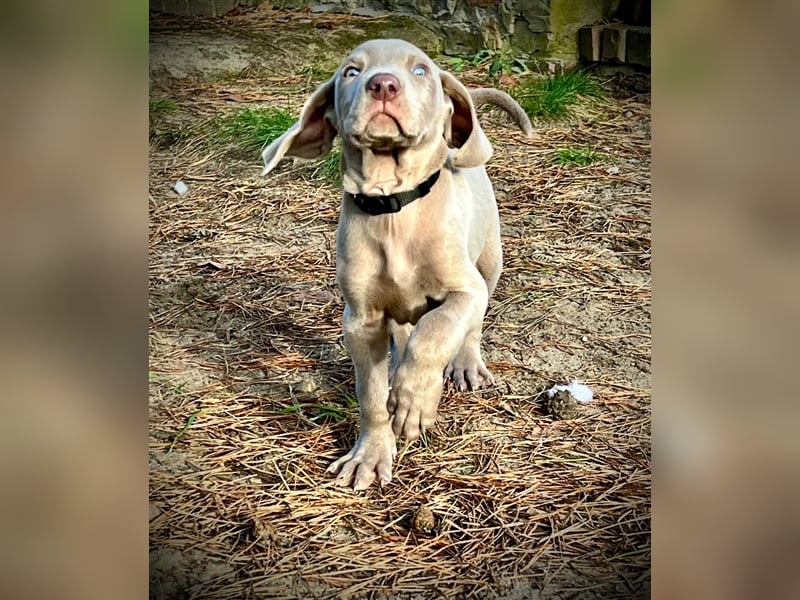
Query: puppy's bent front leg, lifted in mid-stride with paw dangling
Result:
<box><xmin>388</xmin><ymin>278</ymin><xmax>489</xmax><ymax>440</ymax></box>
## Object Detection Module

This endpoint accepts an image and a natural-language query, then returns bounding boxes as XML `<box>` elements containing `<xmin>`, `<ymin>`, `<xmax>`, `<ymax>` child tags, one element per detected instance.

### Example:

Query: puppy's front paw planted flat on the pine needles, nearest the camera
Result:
<box><xmin>326</xmin><ymin>423</ymin><xmax>397</xmax><ymax>490</ymax></box>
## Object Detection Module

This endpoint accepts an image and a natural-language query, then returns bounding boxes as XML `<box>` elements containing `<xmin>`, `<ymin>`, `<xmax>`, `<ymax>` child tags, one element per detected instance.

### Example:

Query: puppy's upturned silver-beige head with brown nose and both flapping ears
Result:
<box><xmin>262</xmin><ymin>40</ymin><xmax>492</xmax><ymax>193</ymax></box>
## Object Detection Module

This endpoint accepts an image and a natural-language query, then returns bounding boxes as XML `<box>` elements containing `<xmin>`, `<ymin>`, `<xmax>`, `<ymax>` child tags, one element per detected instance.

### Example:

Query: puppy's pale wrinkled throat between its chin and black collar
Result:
<box><xmin>342</xmin><ymin>140</ymin><xmax>447</xmax><ymax>196</ymax></box>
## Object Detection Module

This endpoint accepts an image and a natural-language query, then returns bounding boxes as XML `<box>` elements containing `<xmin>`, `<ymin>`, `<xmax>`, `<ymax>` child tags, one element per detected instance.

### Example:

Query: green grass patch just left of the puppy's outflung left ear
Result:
<box><xmin>210</xmin><ymin>108</ymin><xmax>297</xmax><ymax>152</ymax></box>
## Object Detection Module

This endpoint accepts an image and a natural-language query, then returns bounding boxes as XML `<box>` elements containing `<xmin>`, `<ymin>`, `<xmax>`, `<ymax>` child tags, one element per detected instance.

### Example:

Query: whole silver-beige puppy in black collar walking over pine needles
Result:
<box><xmin>263</xmin><ymin>40</ymin><xmax>532</xmax><ymax>489</ymax></box>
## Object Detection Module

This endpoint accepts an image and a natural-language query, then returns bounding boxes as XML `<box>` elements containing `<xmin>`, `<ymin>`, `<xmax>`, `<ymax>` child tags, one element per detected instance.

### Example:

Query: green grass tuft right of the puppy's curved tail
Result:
<box><xmin>511</xmin><ymin>69</ymin><xmax>605</xmax><ymax>121</ymax></box>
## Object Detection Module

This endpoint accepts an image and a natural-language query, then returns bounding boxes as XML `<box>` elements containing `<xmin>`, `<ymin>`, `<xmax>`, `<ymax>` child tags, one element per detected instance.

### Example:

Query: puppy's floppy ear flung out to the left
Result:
<box><xmin>261</xmin><ymin>78</ymin><xmax>337</xmax><ymax>175</ymax></box>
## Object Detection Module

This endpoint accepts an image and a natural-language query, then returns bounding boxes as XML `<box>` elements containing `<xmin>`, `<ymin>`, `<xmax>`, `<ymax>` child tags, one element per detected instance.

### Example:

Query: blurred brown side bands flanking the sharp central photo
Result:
<box><xmin>0</xmin><ymin>0</ymin><xmax>800</xmax><ymax>599</ymax></box>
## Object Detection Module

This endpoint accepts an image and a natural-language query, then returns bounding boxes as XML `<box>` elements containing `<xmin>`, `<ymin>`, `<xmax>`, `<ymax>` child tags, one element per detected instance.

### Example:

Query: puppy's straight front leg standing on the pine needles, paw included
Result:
<box><xmin>328</xmin><ymin>306</ymin><xmax>397</xmax><ymax>490</ymax></box>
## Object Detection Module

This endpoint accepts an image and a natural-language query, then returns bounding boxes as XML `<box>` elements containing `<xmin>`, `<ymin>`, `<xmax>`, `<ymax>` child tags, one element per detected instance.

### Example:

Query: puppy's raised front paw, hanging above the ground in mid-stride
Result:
<box><xmin>387</xmin><ymin>365</ymin><xmax>442</xmax><ymax>441</ymax></box>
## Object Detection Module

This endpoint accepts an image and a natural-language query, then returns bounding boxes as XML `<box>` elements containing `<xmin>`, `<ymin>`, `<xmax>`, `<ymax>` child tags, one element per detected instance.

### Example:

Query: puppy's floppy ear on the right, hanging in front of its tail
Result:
<box><xmin>440</xmin><ymin>71</ymin><xmax>492</xmax><ymax>167</ymax></box>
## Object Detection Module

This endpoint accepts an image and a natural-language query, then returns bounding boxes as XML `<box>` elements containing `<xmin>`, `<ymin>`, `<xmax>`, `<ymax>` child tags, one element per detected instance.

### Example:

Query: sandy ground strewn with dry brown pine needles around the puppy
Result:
<box><xmin>149</xmin><ymin>5</ymin><xmax>651</xmax><ymax>600</ymax></box>
